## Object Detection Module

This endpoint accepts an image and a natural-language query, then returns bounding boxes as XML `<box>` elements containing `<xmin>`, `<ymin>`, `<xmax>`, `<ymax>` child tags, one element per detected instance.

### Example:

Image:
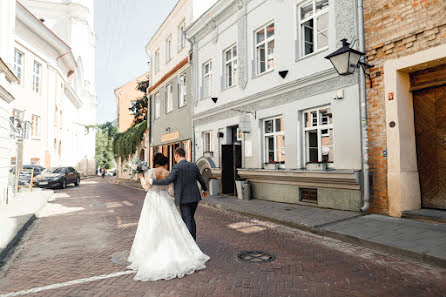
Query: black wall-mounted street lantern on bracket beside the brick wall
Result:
<box><xmin>325</xmin><ymin>38</ymin><xmax>373</xmax><ymax>88</ymax></box>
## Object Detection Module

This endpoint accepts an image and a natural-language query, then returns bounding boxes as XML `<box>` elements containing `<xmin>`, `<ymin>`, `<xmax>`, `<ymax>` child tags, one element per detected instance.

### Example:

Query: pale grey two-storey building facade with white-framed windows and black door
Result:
<box><xmin>187</xmin><ymin>0</ymin><xmax>361</xmax><ymax>211</ymax></box>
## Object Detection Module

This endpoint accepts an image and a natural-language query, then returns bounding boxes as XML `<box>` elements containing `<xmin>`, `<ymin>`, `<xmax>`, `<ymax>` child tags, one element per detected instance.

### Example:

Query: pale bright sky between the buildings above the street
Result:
<box><xmin>95</xmin><ymin>0</ymin><xmax>177</xmax><ymax>124</ymax></box>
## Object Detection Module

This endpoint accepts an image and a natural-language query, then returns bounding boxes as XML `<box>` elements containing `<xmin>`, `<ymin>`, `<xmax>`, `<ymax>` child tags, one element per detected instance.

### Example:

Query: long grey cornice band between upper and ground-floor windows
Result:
<box><xmin>193</xmin><ymin>68</ymin><xmax>358</xmax><ymax>126</ymax></box>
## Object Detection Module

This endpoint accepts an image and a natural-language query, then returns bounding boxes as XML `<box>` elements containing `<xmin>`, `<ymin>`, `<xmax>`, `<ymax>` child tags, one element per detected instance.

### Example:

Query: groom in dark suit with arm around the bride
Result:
<box><xmin>150</xmin><ymin>148</ymin><xmax>208</xmax><ymax>240</ymax></box>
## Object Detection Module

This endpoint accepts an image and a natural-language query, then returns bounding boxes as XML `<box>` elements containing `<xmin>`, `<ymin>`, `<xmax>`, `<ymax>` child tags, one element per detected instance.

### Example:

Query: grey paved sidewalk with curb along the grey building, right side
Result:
<box><xmin>111</xmin><ymin>179</ymin><xmax>446</xmax><ymax>268</ymax></box>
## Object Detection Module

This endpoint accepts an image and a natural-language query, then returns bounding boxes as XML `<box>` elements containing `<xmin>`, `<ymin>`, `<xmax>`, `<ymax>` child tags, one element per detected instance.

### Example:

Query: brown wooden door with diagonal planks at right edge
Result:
<box><xmin>413</xmin><ymin>86</ymin><xmax>446</xmax><ymax>209</ymax></box>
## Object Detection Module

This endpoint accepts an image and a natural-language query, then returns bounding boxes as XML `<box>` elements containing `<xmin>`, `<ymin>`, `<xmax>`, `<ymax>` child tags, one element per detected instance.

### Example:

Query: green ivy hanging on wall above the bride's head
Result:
<box><xmin>113</xmin><ymin>120</ymin><xmax>147</xmax><ymax>160</ymax></box>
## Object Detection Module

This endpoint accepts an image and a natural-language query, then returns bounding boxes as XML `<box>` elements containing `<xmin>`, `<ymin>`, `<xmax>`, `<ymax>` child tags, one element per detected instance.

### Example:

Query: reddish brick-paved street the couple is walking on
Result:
<box><xmin>0</xmin><ymin>179</ymin><xmax>446</xmax><ymax>297</ymax></box>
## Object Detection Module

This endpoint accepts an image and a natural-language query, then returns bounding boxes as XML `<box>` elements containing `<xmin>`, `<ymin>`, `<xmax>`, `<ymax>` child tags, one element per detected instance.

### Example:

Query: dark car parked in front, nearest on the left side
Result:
<box><xmin>34</xmin><ymin>167</ymin><xmax>81</xmax><ymax>189</ymax></box>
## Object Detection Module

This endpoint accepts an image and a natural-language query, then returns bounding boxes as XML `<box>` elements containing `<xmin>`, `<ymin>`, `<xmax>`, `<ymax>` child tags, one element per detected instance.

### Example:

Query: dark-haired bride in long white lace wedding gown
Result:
<box><xmin>128</xmin><ymin>153</ymin><xmax>209</xmax><ymax>281</ymax></box>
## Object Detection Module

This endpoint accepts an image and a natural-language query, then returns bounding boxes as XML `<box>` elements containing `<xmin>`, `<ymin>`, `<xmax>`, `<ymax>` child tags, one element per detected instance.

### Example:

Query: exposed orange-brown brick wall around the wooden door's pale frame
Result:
<box><xmin>364</xmin><ymin>0</ymin><xmax>446</xmax><ymax>214</ymax></box>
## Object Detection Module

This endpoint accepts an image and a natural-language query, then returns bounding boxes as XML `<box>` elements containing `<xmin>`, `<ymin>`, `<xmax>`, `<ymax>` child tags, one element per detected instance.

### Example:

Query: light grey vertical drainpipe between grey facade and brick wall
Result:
<box><xmin>358</xmin><ymin>0</ymin><xmax>370</xmax><ymax>213</ymax></box>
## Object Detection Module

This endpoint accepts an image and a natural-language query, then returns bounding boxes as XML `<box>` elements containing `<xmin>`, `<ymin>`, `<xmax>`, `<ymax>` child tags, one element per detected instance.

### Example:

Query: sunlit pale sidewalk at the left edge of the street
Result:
<box><xmin>0</xmin><ymin>189</ymin><xmax>54</xmax><ymax>263</ymax></box>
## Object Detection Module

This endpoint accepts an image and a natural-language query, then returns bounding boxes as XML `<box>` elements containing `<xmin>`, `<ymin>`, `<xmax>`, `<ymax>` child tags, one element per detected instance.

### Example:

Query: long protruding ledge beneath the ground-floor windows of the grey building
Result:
<box><xmin>237</xmin><ymin>169</ymin><xmax>361</xmax><ymax>190</ymax></box>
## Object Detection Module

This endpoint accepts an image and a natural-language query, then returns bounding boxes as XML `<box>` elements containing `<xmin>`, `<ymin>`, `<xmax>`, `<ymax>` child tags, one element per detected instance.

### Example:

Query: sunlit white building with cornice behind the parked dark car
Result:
<box><xmin>11</xmin><ymin>0</ymin><xmax>96</xmax><ymax>175</ymax></box>
